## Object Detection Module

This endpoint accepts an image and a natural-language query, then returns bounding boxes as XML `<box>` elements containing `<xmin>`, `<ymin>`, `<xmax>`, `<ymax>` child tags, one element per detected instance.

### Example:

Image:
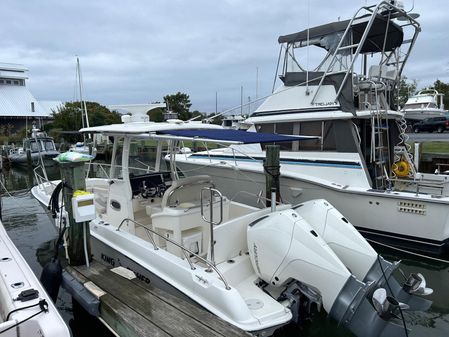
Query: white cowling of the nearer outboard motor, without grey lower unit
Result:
<box><xmin>247</xmin><ymin>209</ymin><xmax>351</xmax><ymax>312</ymax></box>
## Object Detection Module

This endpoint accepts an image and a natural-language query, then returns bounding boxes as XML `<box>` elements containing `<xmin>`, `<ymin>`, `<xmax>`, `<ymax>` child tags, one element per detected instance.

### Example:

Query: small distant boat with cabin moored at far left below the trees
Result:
<box><xmin>7</xmin><ymin>126</ymin><xmax>59</xmax><ymax>167</ymax></box>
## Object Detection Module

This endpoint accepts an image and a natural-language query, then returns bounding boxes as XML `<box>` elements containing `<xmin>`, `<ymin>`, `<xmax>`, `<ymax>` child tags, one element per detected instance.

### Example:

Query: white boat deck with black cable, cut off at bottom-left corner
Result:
<box><xmin>0</xmin><ymin>218</ymin><xmax>70</xmax><ymax>337</ymax></box>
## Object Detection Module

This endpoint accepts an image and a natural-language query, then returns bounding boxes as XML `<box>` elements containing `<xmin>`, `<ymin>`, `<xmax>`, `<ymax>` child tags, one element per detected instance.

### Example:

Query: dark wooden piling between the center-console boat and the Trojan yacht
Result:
<box><xmin>263</xmin><ymin>145</ymin><xmax>281</xmax><ymax>207</ymax></box>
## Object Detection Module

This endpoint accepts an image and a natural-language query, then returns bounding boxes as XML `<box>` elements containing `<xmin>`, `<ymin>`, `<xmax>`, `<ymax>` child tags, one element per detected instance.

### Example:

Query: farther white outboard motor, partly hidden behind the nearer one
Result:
<box><xmin>295</xmin><ymin>199</ymin><xmax>433</xmax><ymax>311</ymax></box>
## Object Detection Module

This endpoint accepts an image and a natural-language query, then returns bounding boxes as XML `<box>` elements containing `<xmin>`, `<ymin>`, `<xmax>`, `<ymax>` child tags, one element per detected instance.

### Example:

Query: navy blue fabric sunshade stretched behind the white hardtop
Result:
<box><xmin>157</xmin><ymin>129</ymin><xmax>318</xmax><ymax>144</ymax></box>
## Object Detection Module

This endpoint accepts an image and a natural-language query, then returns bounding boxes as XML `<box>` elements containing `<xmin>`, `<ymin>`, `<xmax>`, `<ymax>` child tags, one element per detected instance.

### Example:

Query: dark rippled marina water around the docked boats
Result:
<box><xmin>2</xmin><ymin>169</ymin><xmax>449</xmax><ymax>337</ymax></box>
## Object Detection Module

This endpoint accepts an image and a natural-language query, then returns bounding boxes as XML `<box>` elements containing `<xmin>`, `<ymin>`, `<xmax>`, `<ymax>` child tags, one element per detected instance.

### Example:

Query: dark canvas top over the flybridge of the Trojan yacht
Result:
<box><xmin>278</xmin><ymin>15</ymin><xmax>404</xmax><ymax>53</ymax></box>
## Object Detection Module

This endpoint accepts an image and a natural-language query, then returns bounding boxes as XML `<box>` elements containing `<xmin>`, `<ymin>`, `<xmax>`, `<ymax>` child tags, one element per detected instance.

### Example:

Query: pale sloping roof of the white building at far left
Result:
<box><xmin>0</xmin><ymin>85</ymin><xmax>51</xmax><ymax>117</ymax></box>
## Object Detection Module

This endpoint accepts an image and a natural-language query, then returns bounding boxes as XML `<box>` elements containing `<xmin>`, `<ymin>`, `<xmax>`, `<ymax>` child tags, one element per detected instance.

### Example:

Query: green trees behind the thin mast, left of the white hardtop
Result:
<box><xmin>45</xmin><ymin>102</ymin><xmax>121</xmax><ymax>142</ymax></box>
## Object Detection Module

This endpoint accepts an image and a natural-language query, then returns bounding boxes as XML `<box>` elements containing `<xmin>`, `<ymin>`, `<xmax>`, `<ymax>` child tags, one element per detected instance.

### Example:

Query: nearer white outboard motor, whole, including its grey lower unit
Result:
<box><xmin>247</xmin><ymin>209</ymin><xmax>412</xmax><ymax>337</ymax></box>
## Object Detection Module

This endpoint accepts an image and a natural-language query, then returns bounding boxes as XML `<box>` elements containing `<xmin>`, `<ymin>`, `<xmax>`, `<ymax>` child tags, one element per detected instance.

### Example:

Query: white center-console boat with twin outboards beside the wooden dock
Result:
<box><xmin>32</xmin><ymin>116</ymin><xmax>431</xmax><ymax>336</ymax></box>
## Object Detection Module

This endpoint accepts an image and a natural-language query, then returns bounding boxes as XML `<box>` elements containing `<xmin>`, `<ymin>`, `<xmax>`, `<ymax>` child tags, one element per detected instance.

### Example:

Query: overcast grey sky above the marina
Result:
<box><xmin>0</xmin><ymin>0</ymin><xmax>449</xmax><ymax>112</ymax></box>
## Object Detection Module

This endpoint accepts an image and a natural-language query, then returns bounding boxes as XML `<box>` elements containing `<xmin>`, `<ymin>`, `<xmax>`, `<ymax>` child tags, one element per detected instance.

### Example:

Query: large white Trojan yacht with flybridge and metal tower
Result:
<box><xmin>173</xmin><ymin>1</ymin><xmax>449</xmax><ymax>254</ymax></box>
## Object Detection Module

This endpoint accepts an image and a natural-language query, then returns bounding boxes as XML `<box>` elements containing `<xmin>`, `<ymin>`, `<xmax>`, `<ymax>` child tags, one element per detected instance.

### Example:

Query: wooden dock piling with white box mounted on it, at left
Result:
<box><xmin>59</xmin><ymin>162</ymin><xmax>91</xmax><ymax>266</ymax></box>
